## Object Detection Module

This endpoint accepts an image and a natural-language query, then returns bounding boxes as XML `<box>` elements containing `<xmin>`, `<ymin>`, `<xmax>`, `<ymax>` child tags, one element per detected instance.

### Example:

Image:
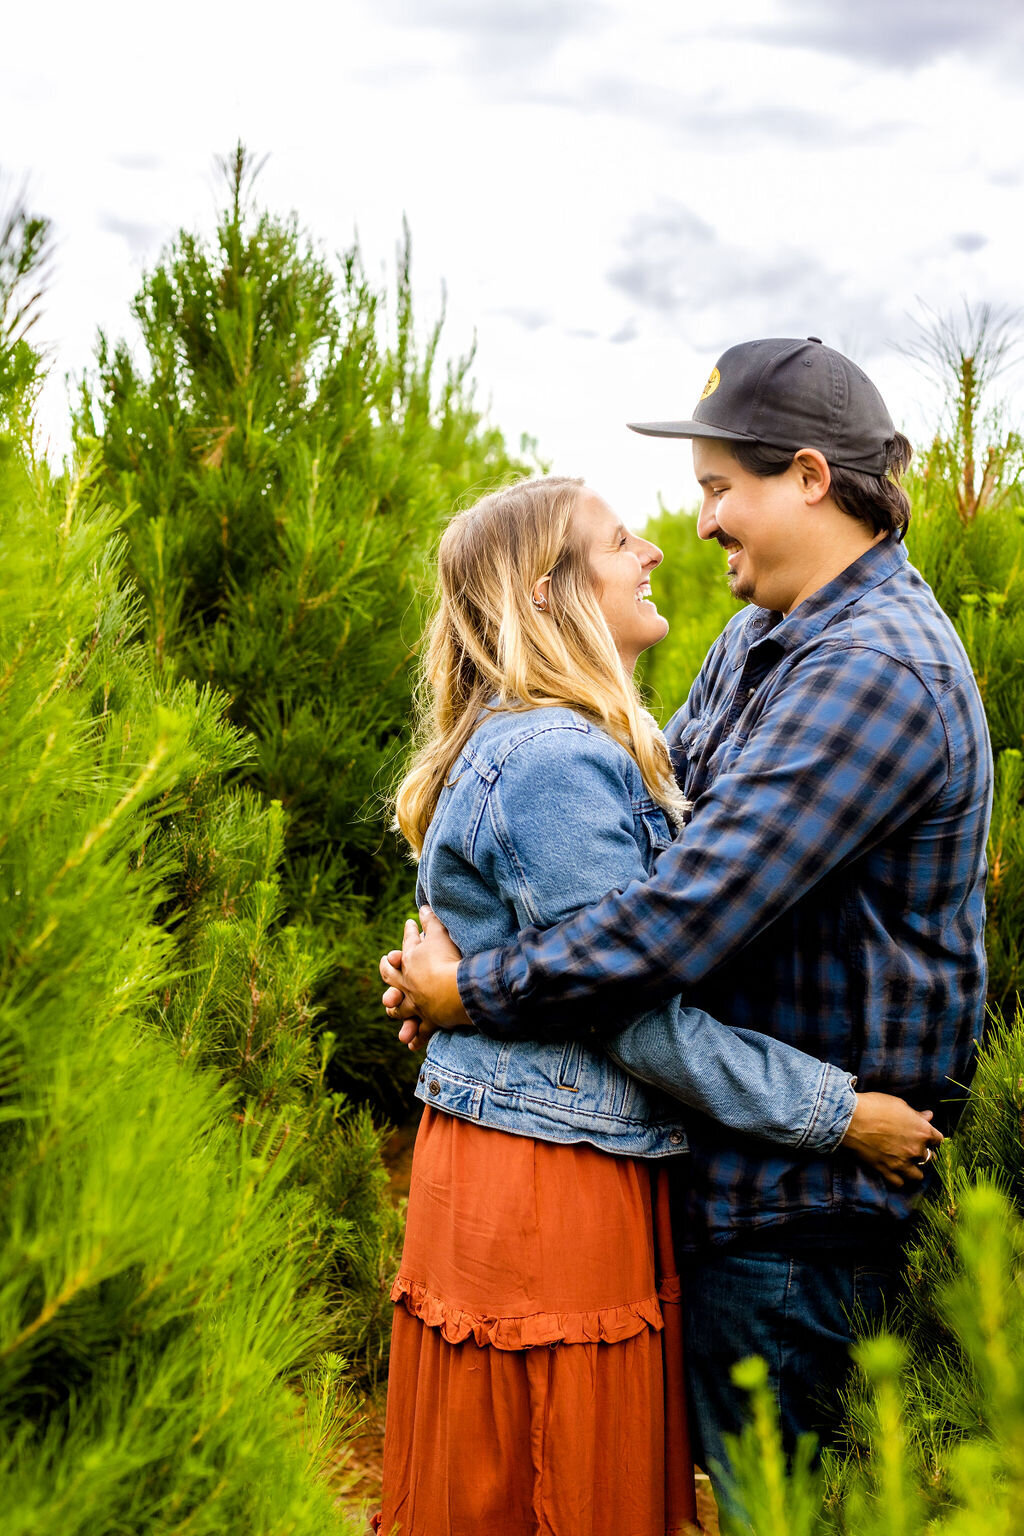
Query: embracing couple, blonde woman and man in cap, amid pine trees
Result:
<box><xmin>379</xmin><ymin>338</ymin><xmax>992</xmax><ymax>1536</ymax></box>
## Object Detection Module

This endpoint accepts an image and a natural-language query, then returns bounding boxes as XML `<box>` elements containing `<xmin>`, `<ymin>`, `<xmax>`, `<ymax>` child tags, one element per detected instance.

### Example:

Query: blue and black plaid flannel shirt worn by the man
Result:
<box><xmin>459</xmin><ymin>539</ymin><xmax>992</xmax><ymax>1246</ymax></box>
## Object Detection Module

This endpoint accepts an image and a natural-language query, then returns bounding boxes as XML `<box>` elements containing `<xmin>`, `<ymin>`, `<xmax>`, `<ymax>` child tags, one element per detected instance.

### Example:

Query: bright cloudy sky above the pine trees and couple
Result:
<box><xmin>0</xmin><ymin>0</ymin><xmax>1024</xmax><ymax>524</ymax></box>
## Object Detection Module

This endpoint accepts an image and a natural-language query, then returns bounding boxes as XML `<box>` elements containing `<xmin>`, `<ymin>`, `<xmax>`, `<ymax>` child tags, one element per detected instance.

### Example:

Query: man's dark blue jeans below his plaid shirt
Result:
<box><xmin>683</xmin><ymin>1235</ymin><xmax>903</xmax><ymax>1499</ymax></box>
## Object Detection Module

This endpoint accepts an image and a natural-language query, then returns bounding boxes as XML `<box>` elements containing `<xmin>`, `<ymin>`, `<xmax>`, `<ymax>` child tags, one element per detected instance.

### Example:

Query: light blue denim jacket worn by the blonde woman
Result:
<box><xmin>416</xmin><ymin>708</ymin><xmax>855</xmax><ymax>1157</ymax></box>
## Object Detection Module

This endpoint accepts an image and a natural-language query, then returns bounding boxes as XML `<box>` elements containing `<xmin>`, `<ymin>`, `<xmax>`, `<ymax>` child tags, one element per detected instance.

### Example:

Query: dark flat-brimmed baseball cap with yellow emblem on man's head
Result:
<box><xmin>629</xmin><ymin>336</ymin><xmax>895</xmax><ymax>475</ymax></box>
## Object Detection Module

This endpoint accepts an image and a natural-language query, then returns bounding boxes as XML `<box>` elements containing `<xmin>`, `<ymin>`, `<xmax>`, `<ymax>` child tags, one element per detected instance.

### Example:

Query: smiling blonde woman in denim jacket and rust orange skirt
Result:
<box><xmin>379</xmin><ymin>479</ymin><xmax>938</xmax><ymax>1536</ymax></box>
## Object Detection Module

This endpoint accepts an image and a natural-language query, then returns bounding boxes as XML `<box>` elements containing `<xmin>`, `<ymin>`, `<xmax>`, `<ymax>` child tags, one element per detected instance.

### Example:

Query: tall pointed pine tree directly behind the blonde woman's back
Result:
<box><xmin>78</xmin><ymin>146</ymin><xmax>519</xmax><ymax>1114</ymax></box>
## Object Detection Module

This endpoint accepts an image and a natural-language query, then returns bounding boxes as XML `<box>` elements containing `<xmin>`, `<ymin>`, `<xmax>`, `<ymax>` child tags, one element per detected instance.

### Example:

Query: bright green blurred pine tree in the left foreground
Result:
<box><xmin>0</xmin><ymin>212</ymin><xmax>362</xmax><ymax>1536</ymax></box>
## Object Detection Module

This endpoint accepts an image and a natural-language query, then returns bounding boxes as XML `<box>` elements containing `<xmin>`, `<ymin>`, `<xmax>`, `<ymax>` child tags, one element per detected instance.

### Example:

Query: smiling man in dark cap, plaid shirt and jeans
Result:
<box><xmin>381</xmin><ymin>338</ymin><xmax>992</xmax><ymax>1486</ymax></box>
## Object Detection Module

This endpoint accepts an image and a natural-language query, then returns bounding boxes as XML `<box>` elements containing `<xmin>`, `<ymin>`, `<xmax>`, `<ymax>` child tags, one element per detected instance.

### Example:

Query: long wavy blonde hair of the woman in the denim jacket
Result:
<box><xmin>395</xmin><ymin>476</ymin><xmax>683</xmax><ymax>852</ymax></box>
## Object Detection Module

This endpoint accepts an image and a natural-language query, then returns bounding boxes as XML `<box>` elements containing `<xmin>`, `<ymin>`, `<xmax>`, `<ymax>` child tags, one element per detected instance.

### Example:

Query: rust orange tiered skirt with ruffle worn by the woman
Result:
<box><xmin>379</xmin><ymin>1107</ymin><xmax>695</xmax><ymax>1536</ymax></box>
